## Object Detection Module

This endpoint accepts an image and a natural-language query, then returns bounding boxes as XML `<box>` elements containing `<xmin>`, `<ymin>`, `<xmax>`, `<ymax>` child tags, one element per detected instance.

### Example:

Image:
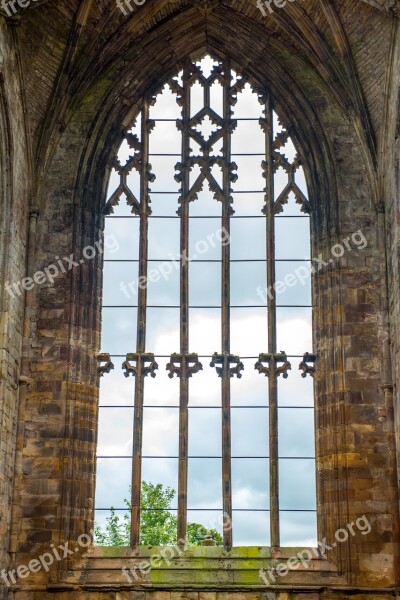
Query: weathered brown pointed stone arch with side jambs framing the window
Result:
<box><xmin>9</xmin><ymin>12</ymin><xmax>396</xmax><ymax>596</ymax></box>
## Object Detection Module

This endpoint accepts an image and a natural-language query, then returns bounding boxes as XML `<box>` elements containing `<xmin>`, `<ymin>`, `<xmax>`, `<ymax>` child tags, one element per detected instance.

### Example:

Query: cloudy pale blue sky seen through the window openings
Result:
<box><xmin>96</xmin><ymin>59</ymin><xmax>316</xmax><ymax>546</ymax></box>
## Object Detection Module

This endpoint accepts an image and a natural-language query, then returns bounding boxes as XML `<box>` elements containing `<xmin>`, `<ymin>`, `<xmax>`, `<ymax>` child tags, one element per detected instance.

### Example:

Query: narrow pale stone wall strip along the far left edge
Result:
<box><xmin>0</xmin><ymin>20</ymin><xmax>29</xmax><ymax>580</ymax></box>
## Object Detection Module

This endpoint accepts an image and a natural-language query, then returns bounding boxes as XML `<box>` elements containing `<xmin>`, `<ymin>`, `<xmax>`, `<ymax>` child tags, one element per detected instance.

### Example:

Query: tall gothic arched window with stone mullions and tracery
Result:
<box><xmin>96</xmin><ymin>55</ymin><xmax>316</xmax><ymax>546</ymax></box>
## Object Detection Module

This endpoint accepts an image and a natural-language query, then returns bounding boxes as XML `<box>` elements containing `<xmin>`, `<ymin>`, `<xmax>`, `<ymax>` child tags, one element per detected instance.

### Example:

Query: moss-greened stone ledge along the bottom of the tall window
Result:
<box><xmin>58</xmin><ymin>546</ymin><xmax>347</xmax><ymax>591</ymax></box>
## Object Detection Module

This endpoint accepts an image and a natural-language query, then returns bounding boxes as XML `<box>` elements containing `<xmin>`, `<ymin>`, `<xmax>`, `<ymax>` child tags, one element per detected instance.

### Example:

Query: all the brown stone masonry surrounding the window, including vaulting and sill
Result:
<box><xmin>0</xmin><ymin>0</ymin><xmax>400</xmax><ymax>600</ymax></box>
